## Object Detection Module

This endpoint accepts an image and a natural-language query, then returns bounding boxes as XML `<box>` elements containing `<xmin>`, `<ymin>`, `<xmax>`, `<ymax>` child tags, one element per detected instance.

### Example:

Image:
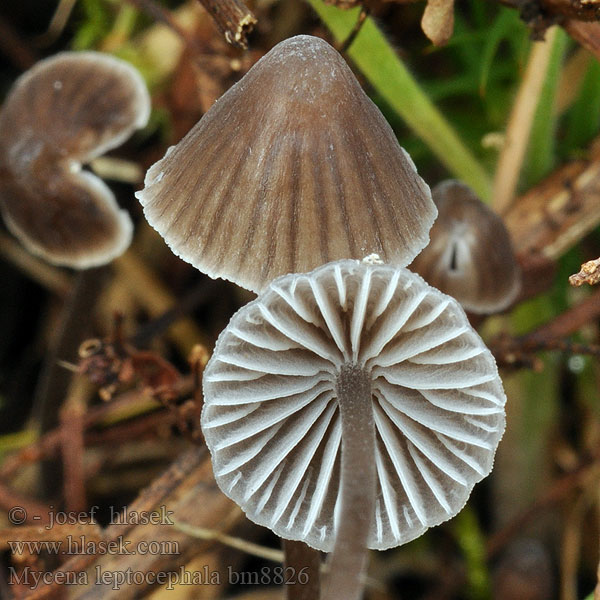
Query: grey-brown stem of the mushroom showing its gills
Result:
<box><xmin>323</xmin><ymin>364</ymin><xmax>376</xmax><ymax>600</ymax></box>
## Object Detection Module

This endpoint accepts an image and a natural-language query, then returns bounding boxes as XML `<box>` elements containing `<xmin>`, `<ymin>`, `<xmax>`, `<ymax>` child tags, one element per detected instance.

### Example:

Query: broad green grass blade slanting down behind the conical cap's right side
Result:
<box><xmin>307</xmin><ymin>0</ymin><xmax>491</xmax><ymax>201</ymax></box>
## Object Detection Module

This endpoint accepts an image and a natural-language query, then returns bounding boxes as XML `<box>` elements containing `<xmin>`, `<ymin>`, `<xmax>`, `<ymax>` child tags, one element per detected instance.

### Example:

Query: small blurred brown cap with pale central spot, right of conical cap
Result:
<box><xmin>410</xmin><ymin>180</ymin><xmax>521</xmax><ymax>313</ymax></box>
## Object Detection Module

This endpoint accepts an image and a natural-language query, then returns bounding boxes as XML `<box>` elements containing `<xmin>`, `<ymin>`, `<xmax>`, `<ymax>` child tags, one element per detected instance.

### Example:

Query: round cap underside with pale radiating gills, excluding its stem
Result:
<box><xmin>202</xmin><ymin>260</ymin><xmax>505</xmax><ymax>551</ymax></box>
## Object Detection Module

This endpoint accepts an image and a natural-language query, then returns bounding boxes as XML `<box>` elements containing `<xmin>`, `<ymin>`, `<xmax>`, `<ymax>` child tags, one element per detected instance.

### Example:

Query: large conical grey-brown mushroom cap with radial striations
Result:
<box><xmin>136</xmin><ymin>35</ymin><xmax>436</xmax><ymax>291</ymax></box>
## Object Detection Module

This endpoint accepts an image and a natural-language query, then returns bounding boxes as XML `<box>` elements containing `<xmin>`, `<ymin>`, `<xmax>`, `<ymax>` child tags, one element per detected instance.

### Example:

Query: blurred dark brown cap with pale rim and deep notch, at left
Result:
<box><xmin>0</xmin><ymin>52</ymin><xmax>150</xmax><ymax>268</ymax></box>
